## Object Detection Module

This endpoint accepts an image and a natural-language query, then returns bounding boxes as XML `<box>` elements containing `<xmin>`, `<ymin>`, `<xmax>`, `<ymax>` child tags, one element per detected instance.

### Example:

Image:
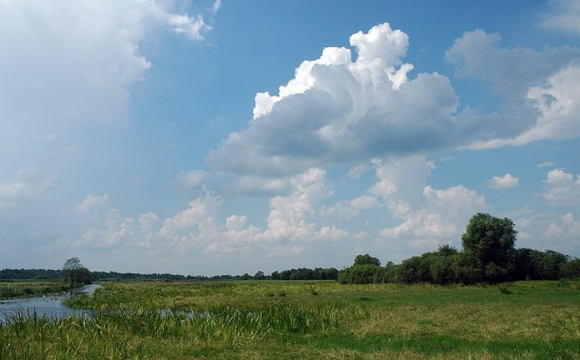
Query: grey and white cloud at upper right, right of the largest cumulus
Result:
<box><xmin>445</xmin><ymin>30</ymin><xmax>580</xmax><ymax>149</ymax></box>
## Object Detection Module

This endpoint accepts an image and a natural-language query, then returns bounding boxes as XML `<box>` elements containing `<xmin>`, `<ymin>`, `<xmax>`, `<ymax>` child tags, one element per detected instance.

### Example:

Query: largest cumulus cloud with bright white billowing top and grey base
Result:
<box><xmin>208</xmin><ymin>24</ymin><xmax>468</xmax><ymax>177</ymax></box>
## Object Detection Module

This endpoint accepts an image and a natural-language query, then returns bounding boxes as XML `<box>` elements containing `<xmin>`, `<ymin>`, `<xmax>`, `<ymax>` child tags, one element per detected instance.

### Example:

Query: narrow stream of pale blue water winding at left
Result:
<box><xmin>0</xmin><ymin>284</ymin><xmax>101</xmax><ymax>322</ymax></box>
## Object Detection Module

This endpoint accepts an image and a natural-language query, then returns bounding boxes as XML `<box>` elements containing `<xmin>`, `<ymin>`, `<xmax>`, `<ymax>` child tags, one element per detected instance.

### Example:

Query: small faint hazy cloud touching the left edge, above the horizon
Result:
<box><xmin>0</xmin><ymin>169</ymin><xmax>58</xmax><ymax>207</ymax></box>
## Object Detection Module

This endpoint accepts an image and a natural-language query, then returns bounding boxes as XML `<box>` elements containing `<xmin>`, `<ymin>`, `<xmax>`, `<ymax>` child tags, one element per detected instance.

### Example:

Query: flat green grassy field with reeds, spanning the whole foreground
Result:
<box><xmin>0</xmin><ymin>281</ymin><xmax>580</xmax><ymax>359</ymax></box>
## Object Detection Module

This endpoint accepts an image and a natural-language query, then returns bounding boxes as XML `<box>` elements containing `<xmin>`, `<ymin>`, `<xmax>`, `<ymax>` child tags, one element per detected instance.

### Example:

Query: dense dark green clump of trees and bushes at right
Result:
<box><xmin>338</xmin><ymin>213</ymin><xmax>580</xmax><ymax>285</ymax></box>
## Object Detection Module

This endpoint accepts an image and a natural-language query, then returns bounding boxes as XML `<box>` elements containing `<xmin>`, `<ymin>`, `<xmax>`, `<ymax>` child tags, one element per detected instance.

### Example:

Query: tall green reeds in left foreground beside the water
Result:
<box><xmin>0</xmin><ymin>304</ymin><xmax>368</xmax><ymax>360</ymax></box>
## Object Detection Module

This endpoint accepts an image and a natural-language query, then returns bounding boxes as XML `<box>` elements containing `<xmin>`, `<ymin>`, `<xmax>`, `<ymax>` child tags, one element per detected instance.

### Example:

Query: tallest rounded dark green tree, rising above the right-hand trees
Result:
<box><xmin>461</xmin><ymin>213</ymin><xmax>517</xmax><ymax>282</ymax></box>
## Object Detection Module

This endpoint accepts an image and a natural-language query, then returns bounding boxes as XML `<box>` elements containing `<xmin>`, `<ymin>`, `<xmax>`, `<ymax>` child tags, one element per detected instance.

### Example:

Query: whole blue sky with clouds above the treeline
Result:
<box><xmin>0</xmin><ymin>0</ymin><xmax>580</xmax><ymax>276</ymax></box>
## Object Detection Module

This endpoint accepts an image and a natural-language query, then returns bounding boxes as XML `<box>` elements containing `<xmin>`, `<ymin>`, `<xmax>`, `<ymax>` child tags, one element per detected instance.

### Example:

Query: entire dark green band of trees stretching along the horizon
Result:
<box><xmin>0</xmin><ymin>213</ymin><xmax>580</xmax><ymax>285</ymax></box>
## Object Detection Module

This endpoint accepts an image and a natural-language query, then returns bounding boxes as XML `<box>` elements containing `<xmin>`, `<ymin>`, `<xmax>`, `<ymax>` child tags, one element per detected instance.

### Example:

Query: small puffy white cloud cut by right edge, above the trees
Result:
<box><xmin>544</xmin><ymin>169</ymin><xmax>580</xmax><ymax>206</ymax></box>
